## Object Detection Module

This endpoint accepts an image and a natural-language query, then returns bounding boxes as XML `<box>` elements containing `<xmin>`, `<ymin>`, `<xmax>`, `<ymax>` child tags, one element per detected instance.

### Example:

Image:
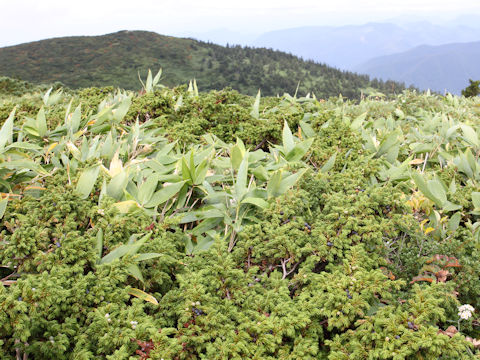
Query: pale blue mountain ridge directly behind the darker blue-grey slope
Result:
<box><xmin>252</xmin><ymin>21</ymin><xmax>480</xmax><ymax>70</ymax></box>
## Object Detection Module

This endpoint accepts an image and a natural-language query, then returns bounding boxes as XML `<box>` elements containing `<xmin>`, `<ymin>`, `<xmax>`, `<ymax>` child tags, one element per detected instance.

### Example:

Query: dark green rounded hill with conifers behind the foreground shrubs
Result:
<box><xmin>0</xmin><ymin>31</ymin><xmax>404</xmax><ymax>98</ymax></box>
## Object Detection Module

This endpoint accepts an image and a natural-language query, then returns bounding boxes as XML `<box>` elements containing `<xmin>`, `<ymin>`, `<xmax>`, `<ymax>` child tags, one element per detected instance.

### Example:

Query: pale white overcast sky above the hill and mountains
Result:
<box><xmin>0</xmin><ymin>0</ymin><xmax>480</xmax><ymax>47</ymax></box>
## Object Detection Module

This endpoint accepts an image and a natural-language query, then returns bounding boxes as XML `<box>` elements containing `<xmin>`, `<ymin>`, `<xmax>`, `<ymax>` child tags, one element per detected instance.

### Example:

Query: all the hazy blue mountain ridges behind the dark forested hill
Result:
<box><xmin>185</xmin><ymin>14</ymin><xmax>480</xmax><ymax>94</ymax></box>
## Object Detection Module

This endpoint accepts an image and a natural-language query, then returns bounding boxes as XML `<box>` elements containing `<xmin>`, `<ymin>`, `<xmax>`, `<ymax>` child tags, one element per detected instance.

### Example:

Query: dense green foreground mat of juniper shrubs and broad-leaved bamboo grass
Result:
<box><xmin>0</xmin><ymin>73</ymin><xmax>480</xmax><ymax>360</ymax></box>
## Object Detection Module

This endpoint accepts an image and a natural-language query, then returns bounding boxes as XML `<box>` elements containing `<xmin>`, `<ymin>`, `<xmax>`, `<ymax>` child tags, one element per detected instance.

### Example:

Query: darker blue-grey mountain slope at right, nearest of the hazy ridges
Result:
<box><xmin>356</xmin><ymin>41</ymin><xmax>480</xmax><ymax>94</ymax></box>
